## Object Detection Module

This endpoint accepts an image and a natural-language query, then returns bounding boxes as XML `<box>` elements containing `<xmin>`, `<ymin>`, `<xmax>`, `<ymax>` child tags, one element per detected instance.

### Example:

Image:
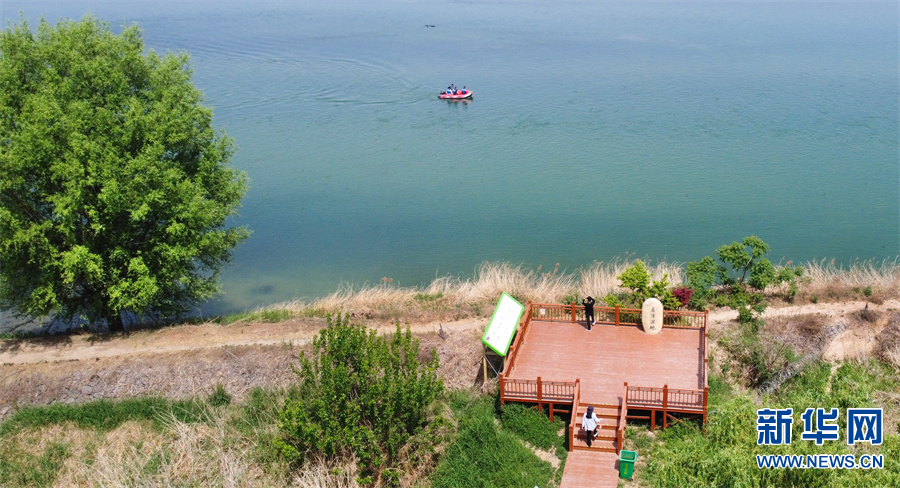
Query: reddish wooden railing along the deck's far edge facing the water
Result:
<box><xmin>529</xmin><ymin>303</ymin><xmax>709</xmax><ymax>329</ymax></box>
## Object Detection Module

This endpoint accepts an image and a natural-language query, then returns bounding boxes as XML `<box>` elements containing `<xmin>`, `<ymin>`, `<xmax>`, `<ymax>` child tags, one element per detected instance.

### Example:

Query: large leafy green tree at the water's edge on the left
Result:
<box><xmin>0</xmin><ymin>16</ymin><xmax>249</xmax><ymax>330</ymax></box>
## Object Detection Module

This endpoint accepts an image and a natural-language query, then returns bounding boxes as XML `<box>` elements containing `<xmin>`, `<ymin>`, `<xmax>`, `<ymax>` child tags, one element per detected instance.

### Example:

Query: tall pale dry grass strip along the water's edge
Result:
<box><xmin>218</xmin><ymin>260</ymin><xmax>900</xmax><ymax>323</ymax></box>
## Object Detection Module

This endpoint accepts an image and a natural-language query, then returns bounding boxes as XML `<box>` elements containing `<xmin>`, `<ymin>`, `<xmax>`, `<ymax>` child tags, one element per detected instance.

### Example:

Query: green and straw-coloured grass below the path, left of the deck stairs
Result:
<box><xmin>0</xmin><ymin>388</ymin><xmax>566</xmax><ymax>488</ymax></box>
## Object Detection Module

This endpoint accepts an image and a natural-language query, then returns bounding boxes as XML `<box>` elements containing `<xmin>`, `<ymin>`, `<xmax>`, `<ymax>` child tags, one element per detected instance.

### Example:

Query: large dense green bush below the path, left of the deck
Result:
<box><xmin>277</xmin><ymin>315</ymin><xmax>443</xmax><ymax>484</ymax></box>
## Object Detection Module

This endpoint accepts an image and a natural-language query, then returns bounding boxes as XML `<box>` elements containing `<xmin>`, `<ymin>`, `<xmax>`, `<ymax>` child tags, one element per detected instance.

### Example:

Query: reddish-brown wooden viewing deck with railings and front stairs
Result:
<box><xmin>499</xmin><ymin>302</ymin><xmax>709</xmax><ymax>488</ymax></box>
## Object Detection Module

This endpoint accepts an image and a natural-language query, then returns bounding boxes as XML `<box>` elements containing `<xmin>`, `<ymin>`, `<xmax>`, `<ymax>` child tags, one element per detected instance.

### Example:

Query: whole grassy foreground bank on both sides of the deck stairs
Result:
<box><xmin>0</xmin><ymin>359</ymin><xmax>900</xmax><ymax>488</ymax></box>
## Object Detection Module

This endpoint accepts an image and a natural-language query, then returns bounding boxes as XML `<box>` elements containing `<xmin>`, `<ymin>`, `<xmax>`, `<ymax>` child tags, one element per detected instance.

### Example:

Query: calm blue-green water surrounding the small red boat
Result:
<box><xmin>0</xmin><ymin>0</ymin><xmax>900</xmax><ymax>314</ymax></box>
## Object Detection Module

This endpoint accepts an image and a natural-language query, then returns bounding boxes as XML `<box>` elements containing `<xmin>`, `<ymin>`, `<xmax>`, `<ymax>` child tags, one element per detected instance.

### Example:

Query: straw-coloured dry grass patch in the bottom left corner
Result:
<box><xmin>4</xmin><ymin>411</ymin><xmax>370</xmax><ymax>488</ymax></box>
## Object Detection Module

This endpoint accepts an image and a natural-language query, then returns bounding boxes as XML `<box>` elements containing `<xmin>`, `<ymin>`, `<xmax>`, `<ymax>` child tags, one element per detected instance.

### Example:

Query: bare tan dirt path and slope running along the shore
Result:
<box><xmin>0</xmin><ymin>300</ymin><xmax>900</xmax><ymax>420</ymax></box>
